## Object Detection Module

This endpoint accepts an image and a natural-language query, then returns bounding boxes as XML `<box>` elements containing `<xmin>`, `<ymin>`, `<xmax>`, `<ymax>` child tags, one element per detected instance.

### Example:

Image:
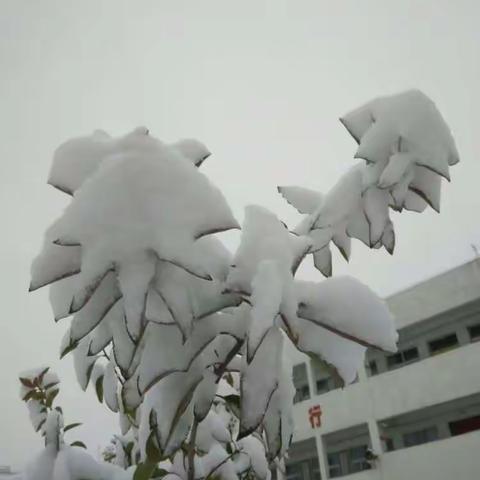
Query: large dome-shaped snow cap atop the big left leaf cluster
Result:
<box><xmin>47</xmin><ymin>129</ymin><xmax>238</xmax><ymax>282</ymax></box>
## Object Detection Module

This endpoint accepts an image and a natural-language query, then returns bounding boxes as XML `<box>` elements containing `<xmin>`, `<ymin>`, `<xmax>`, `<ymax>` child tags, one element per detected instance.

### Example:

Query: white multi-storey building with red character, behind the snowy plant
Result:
<box><xmin>286</xmin><ymin>260</ymin><xmax>480</xmax><ymax>480</ymax></box>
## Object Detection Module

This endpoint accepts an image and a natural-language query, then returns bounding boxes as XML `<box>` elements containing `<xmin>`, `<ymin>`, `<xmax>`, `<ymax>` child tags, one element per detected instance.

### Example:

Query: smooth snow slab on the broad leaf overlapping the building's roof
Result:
<box><xmin>295</xmin><ymin>277</ymin><xmax>398</xmax><ymax>351</ymax></box>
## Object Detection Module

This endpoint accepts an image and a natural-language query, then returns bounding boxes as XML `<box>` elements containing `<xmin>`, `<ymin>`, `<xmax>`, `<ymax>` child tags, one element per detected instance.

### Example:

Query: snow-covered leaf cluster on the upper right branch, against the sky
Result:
<box><xmin>279</xmin><ymin>90</ymin><xmax>459</xmax><ymax>276</ymax></box>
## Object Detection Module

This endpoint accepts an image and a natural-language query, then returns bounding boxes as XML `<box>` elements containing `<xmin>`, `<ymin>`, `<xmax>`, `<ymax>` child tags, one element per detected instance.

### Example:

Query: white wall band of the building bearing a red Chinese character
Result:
<box><xmin>294</xmin><ymin>343</ymin><xmax>480</xmax><ymax>440</ymax></box>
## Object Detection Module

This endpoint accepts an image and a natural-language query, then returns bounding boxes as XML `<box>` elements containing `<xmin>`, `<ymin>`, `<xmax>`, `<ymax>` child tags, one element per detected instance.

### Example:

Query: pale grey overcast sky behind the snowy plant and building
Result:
<box><xmin>0</xmin><ymin>0</ymin><xmax>480</xmax><ymax>466</ymax></box>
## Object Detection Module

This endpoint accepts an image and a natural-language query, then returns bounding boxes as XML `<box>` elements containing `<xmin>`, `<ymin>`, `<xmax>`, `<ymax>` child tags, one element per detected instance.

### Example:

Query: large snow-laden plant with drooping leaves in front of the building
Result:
<box><xmin>30</xmin><ymin>90</ymin><xmax>458</xmax><ymax>480</ymax></box>
